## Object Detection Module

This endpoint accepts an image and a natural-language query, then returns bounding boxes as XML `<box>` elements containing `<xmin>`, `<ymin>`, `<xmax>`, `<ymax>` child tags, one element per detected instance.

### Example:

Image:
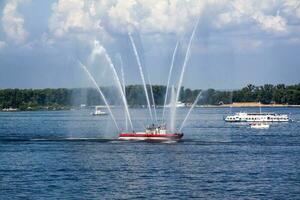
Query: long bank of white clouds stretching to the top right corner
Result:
<box><xmin>47</xmin><ymin>0</ymin><xmax>300</xmax><ymax>53</ymax></box>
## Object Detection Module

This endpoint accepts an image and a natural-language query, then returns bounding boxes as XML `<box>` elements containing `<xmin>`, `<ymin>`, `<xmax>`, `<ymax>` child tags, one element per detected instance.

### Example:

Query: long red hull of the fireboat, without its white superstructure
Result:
<box><xmin>119</xmin><ymin>133</ymin><xmax>183</xmax><ymax>141</ymax></box>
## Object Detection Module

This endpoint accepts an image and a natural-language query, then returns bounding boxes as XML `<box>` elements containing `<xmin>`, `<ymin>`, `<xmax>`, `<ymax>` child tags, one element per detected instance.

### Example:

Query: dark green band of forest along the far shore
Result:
<box><xmin>0</xmin><ymin>84</ymin><xmax>300</xmax><ymax>110</ymax></box>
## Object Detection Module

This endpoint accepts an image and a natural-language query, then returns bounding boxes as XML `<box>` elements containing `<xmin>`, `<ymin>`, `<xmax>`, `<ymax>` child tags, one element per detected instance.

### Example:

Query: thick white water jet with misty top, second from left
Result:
<box><xmin>95</xmin><ymin>41</ymin><xmax>133</xmax><ymax>130</ymax></box>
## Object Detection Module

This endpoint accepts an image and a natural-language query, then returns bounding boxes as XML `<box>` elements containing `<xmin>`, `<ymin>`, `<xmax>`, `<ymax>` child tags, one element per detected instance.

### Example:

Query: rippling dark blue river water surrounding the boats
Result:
<box><xmin>0</xmin><ymin>108</ymin><xmax>300</xmax><ymax>199</ymax></box>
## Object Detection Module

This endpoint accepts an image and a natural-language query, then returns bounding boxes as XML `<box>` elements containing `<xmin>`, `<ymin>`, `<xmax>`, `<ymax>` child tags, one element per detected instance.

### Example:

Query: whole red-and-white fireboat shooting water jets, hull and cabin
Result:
<box><xmin>119</xmin><ymin>124</ymin><xmax>183</xmax><ymax>141</ymax></box>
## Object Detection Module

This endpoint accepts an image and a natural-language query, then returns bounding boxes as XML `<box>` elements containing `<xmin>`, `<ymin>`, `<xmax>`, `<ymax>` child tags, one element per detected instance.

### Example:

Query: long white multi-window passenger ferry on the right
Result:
<box><xmin>225</xmin><ymin>112</ymin><xmax>290</xmax><ymax>122</ymax></box>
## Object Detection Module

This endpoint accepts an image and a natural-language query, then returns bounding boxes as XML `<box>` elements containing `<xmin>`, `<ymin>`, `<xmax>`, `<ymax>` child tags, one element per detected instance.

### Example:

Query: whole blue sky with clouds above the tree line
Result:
<box><xmin>0</xmin><ymin>0</ymin><xmax>300</xmax><ymax>89</ymax></box>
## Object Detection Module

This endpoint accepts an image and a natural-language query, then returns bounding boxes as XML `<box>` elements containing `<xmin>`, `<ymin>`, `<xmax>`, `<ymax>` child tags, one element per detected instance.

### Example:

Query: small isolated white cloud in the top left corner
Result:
<box><xmin>2</xmin><ymin>0</ymin><xmax>28</xmax><ymax>43</ymax></box>
